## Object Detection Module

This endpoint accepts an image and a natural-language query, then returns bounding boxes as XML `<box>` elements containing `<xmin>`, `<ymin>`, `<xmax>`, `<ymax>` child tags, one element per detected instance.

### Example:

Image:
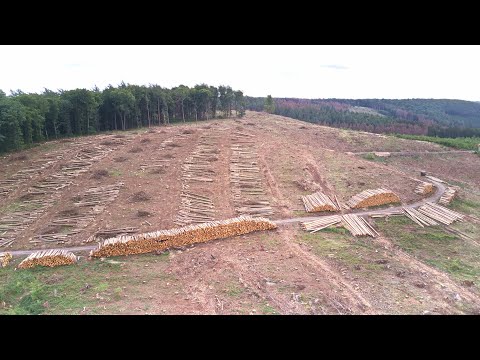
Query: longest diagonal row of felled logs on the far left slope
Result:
<box><xmin>0</xmin><ymin>141</ymin><xmax>126</xmax><ymax>247</ymax></box>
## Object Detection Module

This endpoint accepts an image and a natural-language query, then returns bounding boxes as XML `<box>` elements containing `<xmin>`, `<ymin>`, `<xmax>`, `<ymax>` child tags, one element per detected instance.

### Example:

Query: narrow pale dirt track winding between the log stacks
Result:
<box><xmin>2</xmin><ymin>181</ymin><xmax>445</xmax><ymax>256</ymax></box>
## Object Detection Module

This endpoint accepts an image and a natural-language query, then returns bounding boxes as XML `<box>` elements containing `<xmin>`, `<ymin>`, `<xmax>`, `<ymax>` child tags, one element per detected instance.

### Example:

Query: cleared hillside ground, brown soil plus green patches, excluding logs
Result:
<box><xmin>0</xmin><ymin>112</ymin><xmax>480</xmax><ymax>314</ymax></box>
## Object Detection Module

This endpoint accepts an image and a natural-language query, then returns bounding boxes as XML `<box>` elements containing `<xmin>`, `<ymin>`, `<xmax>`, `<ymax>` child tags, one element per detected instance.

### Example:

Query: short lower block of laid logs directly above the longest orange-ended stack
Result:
<box><xmin>175</xmin><ymin>191</ymin><xmax>215</xmax><ymax>226</ymax></box>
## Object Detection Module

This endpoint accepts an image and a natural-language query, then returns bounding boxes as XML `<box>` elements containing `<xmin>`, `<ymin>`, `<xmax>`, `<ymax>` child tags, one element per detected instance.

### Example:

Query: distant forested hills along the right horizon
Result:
<box><xmin>246</xmin><ymin>97</ymin><xmax>480</xmax><ymax>137</ymax></box>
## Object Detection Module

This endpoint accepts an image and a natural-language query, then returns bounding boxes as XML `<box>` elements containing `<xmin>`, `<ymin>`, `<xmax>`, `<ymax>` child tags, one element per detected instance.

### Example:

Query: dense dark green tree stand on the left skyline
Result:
<box><xmin>0</xmin><ymin>82</ymin><xmax>245</xmax><ymax>152</ymax></box>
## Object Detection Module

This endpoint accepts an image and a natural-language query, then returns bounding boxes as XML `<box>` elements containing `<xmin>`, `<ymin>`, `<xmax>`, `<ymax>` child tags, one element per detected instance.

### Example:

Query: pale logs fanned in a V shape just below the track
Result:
<box><xmin>302</xmin><ymin>214</ymin><xmax>378</xmax><ymax>237</ymax></box>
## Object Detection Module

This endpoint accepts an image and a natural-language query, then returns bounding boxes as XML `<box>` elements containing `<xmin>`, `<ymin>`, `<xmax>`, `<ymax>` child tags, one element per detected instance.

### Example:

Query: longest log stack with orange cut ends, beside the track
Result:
<box><xmin>90</xmin><ymin>216</ymin><xmax>277</xmax><ymax>257</ymax></box>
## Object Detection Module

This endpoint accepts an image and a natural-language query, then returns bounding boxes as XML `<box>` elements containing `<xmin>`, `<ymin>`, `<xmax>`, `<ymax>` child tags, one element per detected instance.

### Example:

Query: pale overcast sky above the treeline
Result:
<box><xmin>0</xmin><ymin>45</ymin><xmax>480</xmax><ymax>101</ymax></box>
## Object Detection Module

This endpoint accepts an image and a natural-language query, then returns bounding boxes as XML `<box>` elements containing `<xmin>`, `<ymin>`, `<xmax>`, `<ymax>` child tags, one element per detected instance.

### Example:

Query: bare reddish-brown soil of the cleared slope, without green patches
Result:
<box><xmin>0</xmin><ymin>112</ymin><xmax>480</xmax><ymax>314</ymax></box>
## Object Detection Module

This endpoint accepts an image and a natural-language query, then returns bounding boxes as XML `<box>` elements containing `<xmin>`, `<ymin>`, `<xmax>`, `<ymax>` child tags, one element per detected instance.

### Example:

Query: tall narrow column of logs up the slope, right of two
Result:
<box><xmin>230</xmin><ymin>131</ymin><xmax>273</xmax><ymax>216</ymax></box>
